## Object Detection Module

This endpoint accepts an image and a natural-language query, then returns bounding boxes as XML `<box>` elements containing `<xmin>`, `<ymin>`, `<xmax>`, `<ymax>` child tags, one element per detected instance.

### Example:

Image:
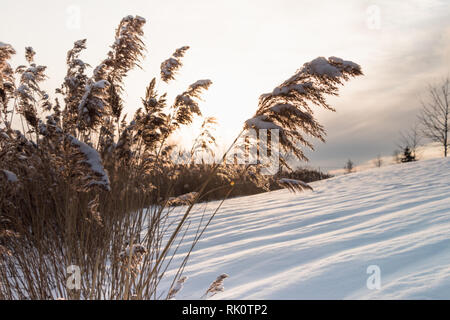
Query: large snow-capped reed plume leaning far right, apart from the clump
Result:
<box><xmin>245</xmin><ymin>57</ymin><xmax>362</xmax><ymax>166</ymax></box>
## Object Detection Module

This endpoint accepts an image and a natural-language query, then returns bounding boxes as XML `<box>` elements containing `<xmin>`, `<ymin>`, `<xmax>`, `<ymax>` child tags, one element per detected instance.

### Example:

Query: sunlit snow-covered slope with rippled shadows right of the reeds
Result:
<box><xmin>164</xmin><ymin>159</ymin><xmax>450</xmax><ymax>299</ymax></box>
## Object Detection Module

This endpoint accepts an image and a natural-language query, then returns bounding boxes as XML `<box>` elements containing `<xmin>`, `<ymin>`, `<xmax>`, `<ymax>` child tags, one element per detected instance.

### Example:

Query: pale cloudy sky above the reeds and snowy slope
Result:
<box><xmin>0</xmin><ymin>0</ymin><xmax>450</xmax><ymax>170</ymax></box>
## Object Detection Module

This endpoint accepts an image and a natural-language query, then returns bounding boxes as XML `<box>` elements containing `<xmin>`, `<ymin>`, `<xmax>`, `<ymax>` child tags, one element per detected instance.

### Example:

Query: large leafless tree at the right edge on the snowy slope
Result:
<box><xmin>419</xmin><ymin>77</ymin><xmax>450</xmax><ymax>157</ymax></box>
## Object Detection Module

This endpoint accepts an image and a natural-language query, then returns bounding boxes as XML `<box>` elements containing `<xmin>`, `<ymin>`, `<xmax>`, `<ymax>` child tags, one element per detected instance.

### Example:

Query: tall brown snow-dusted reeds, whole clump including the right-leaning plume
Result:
<box><xmin>0</xmin><ymin>16</ymin><xmax>361</xmax><ymax>299</ymax></box>
